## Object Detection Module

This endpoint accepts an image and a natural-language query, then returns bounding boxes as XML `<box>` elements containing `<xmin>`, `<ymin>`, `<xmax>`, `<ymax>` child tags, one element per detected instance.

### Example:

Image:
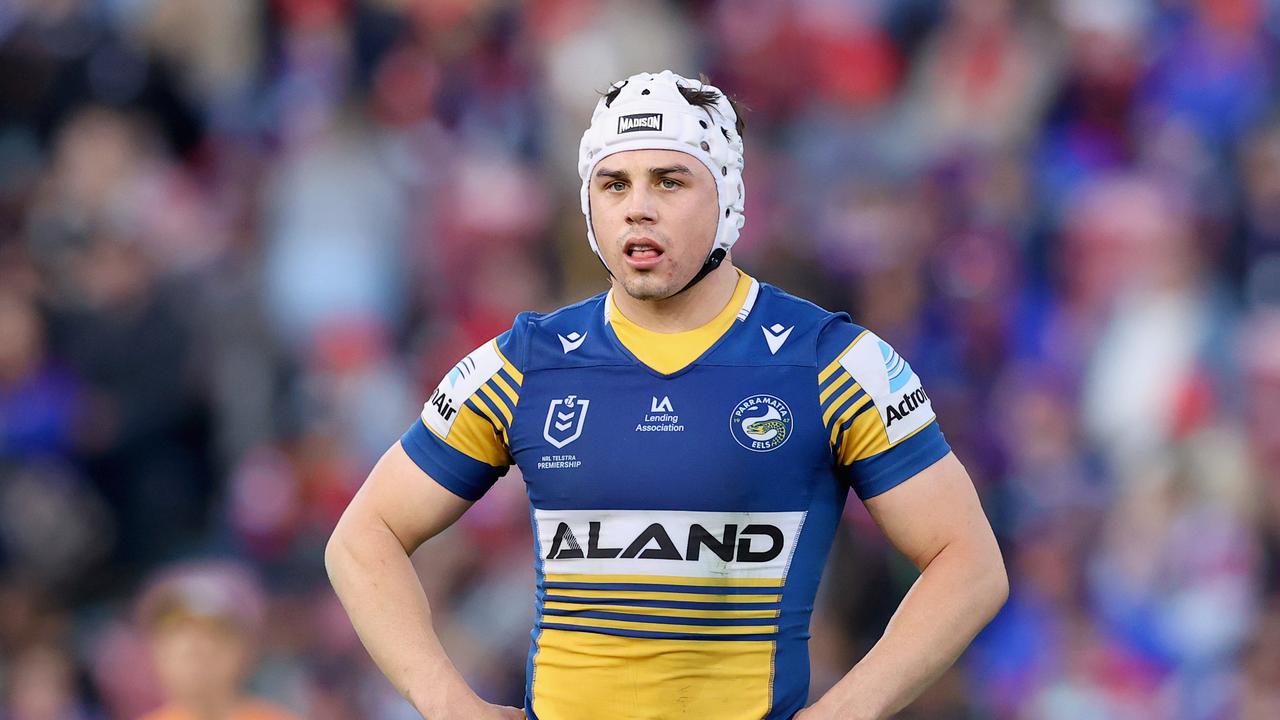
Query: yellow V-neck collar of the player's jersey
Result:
<box><xmin>608</xmin><ymin>268</ymin><xmax>756</xmax><ymax>375</ymax></box>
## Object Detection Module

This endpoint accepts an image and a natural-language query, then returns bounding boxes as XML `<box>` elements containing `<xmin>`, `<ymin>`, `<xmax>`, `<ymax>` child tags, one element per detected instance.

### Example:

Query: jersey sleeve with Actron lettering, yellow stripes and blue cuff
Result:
<box><xmin>818</xmin><ymin>319</ymin><xmax>951</xmax><ymax>500</ymax></box>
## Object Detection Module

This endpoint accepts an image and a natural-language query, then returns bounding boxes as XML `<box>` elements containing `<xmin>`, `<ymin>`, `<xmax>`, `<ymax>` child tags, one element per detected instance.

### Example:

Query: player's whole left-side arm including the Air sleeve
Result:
<box><xmin>325</xmin><ymin>333</ymin><xmax>524</xmax><ymax>720</ymax></box>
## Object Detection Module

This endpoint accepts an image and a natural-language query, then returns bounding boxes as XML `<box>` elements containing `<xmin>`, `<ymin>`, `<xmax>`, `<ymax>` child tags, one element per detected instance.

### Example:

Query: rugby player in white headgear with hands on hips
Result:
<box><xmin>325</xmin><ymin>72</ymin><xmax>1007</xmax><ymax>720</ymax></box>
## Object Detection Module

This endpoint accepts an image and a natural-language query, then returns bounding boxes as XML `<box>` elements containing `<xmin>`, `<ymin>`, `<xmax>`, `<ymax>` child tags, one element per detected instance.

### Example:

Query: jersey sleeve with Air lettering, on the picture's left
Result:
<box><xmin>401</xmin><ymin>320</ymin><xmax>525</xmax><ymax>500</ymax></box>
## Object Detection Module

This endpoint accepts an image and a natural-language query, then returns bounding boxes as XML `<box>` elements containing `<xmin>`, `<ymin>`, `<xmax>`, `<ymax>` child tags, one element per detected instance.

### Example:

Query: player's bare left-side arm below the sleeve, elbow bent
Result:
<box><xmin>325</xmin><ymin>443</ymin><xmax>524</xmax><ymax>720</ymax></box>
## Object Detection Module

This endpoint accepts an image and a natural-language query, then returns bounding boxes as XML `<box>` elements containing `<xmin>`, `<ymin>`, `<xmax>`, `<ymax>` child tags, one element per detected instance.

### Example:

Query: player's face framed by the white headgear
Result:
<box><xmin>589</xmin><ymin>150</ymin><xmax>719</xmax><ymax>300</ymax></box>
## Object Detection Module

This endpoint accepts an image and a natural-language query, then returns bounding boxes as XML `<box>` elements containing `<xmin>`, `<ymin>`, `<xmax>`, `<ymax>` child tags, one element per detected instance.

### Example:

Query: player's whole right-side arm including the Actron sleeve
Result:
<box><xmin>799</xmin><ymin>323</ymin><xmax>1009</xmax><ymax>720</ymax></box>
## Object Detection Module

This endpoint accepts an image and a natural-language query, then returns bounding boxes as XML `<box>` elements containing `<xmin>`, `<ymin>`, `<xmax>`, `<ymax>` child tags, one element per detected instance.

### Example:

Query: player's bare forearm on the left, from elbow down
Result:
<box><xmin>325</xmin><ymin>519</ymin><xmax>481</xmax><ymax>720</ymax></box>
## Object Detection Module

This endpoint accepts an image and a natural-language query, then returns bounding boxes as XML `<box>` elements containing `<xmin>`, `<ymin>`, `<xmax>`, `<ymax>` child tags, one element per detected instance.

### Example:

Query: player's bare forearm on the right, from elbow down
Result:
<box><xmin>818</xmin><ymin>539</ymin><xmax>1009</xmax><ymax>720</ymax></box>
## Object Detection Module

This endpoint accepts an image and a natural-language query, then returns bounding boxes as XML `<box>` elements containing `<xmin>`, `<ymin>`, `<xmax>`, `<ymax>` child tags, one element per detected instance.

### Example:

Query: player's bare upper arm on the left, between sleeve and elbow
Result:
<box><xmin>342</xmin><ymin>442</ymin><xmax>471</xmax><ymax>553</ymax></box>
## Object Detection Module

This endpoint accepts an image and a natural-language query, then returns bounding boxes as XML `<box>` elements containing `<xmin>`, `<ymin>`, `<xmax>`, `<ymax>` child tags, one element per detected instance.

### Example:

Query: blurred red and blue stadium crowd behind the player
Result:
<box><xmin>0</xmin><ymin>0</ymin><xmax>1280</xmax><ymax>720</ymax></box>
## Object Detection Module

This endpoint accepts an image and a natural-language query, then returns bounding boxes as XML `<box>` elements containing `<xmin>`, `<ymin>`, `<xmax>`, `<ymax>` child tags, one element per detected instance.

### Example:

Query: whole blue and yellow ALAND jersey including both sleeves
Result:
<box><xmin>402</xmin><ymin>273</ymin><xmax>948</xmax><ymax>720</ymax></box>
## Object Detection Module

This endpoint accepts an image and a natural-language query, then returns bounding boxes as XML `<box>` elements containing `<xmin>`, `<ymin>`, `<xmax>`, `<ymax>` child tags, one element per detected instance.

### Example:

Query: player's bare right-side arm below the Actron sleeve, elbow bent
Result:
<box><xmin>796</xmin><ymin>454</ymin><xmax>1009</xmax><ymax>720</ymax></box>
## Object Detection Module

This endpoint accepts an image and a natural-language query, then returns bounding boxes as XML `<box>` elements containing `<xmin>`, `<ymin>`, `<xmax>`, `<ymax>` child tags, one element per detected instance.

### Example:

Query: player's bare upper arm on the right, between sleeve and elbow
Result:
<box><xmin>865</xmin><ymin>452</ymin><xmax>995</xmax><ymax>570</ymax></box>
